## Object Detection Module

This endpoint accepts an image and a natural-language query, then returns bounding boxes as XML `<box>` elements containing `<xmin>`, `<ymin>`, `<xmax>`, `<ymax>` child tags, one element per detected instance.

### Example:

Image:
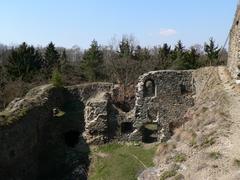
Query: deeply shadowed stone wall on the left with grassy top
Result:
<box><xmin>0</xmin><ymin>83</ymin><xmax>112</xmax><ymax>180</ymax></box>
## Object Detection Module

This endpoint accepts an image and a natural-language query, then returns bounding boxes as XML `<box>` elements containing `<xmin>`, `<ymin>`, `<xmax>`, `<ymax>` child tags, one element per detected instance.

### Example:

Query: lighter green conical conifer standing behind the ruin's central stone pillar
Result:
<box><xmin>80</xmin><ymin>40</ymin><xmax>104</xmax><ymax>81</ymax></box>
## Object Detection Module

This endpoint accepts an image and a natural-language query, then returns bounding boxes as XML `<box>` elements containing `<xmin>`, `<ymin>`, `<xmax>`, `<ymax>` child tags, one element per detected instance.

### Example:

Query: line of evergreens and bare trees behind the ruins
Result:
<box><xmin>0</xmin><ymin>37</ymin><xmax>227</xmax><ymax>108</ymax></box>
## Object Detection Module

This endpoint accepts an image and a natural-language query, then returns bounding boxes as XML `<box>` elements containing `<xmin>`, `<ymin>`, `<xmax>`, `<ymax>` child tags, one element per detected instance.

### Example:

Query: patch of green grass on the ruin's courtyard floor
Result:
<box><xmin>89</xmin><ymin>144</ymin><xmax>156</xmax><ymax>180</ymax></box>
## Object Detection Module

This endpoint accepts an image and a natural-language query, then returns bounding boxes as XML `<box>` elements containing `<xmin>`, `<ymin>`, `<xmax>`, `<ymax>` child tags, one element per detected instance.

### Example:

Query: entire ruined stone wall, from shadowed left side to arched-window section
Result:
<box><xmin>0</xmin><ymin>71</ymin><xmax>195</xmax><ymax>180</ymax></box>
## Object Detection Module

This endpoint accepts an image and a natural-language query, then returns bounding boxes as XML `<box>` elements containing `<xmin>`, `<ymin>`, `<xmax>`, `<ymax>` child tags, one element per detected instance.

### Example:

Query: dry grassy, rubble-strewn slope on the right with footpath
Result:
<box><xmin>138</xmin><ymin>67</ymin><xmax>240</xmax><ymax>180</ymax></box>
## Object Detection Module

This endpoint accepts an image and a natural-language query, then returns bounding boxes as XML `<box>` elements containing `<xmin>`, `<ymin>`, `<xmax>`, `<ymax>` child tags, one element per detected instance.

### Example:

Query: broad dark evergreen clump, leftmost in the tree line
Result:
<box><xmin>6</xmin><ymin>42</ymin><xmax>42</xmax><ymax>80</ymax></box>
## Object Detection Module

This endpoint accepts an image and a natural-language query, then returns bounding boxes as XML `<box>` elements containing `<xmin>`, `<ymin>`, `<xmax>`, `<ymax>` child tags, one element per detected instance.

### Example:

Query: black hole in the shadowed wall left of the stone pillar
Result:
<box><xmin>64</xmin><ymin>130</ymin><xmax>80</xmax><ymax>148</ymax></box>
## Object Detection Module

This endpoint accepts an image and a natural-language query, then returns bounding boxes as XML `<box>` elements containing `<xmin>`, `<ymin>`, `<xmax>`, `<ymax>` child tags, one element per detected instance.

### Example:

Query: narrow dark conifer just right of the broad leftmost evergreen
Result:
<box><xmin>44</xmin><ymin>42</ymin><xmax>60</xmax><ymax>71</ymax></box>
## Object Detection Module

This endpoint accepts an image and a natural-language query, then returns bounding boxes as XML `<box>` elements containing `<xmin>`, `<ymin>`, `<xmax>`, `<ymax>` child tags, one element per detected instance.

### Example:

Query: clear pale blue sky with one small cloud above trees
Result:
<box><xmin>0</xmin><ymin>0</ymin><xmax>237</xmax><ymax>48</ymax></box>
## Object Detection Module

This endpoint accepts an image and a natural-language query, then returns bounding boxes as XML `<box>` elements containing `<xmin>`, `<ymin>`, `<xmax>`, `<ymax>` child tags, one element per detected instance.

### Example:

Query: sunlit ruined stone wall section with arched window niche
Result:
<box><xmin>132</xmin><ymin>70</ymin><xmax>195</xmax><ymax>141</ymax></box>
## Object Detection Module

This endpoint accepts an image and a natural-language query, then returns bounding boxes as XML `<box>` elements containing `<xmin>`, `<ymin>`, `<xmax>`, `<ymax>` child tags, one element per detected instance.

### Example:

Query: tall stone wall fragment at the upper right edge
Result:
<box><xmin>228</xmin><ymin>5</ymin><xmax>240</xmax><ymax>79</ymax></box>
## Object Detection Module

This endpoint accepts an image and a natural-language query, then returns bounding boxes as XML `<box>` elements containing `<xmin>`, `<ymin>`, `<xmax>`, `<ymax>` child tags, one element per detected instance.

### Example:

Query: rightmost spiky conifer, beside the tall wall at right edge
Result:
<box><xmin>204</xmin><ymin>38</ymin><xmax>221</xmax><ymax>66</ymax></box>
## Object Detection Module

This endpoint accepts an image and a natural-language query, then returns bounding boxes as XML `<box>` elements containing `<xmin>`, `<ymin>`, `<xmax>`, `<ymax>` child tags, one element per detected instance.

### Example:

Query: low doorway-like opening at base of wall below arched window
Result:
<box><xmin>142</xmin><ymin>123</ymin><xmax>158</xmax><ymax>143</ymax></box>
